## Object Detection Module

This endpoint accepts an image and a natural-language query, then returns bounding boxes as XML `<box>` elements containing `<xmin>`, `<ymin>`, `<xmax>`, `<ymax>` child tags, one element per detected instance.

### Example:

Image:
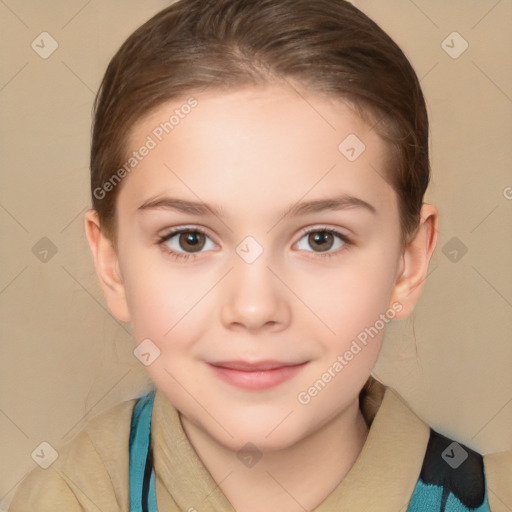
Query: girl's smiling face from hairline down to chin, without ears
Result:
<box><xmin>111</xmin><ymin>85</ymin><xmax>402</xmax><ymax>450</ymax></box>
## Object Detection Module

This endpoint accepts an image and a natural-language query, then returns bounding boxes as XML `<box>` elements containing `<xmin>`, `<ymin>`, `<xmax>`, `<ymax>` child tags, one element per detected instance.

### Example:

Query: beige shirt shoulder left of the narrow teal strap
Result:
<box><xmin>9</xmin><ymin>399</ymin><xmax>141</xmax><ymax>512</ymax></box>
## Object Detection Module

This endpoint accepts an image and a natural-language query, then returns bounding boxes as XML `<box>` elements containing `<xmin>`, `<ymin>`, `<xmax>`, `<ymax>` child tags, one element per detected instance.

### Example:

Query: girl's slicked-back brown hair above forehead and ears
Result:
<box><xmin>91</xmin><ymin>0</ymin><xmax>430</xmax><ymax>243</ymax></box>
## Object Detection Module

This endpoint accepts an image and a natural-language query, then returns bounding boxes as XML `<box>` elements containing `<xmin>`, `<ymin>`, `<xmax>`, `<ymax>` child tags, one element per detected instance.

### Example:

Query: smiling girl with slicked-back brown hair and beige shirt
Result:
<box><xmin>10</xmin><ymin>0</ymin><xmax>510</xmax><ymax>512</ymax></box>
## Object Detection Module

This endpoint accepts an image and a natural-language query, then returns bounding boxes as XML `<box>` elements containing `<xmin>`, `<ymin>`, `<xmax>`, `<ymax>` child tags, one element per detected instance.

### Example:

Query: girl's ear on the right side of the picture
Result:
<box><xmin>390</xmin><ymin>204</ymin><xmax>439</xmax><ymax>318</ymax></box>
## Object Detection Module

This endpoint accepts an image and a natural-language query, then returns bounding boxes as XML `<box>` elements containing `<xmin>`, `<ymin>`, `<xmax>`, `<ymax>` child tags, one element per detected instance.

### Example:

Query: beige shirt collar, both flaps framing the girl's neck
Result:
<box><xmin>151</xmin><ymin>377</ymin><xmax>430</xmax><ymax>512</ymax></box>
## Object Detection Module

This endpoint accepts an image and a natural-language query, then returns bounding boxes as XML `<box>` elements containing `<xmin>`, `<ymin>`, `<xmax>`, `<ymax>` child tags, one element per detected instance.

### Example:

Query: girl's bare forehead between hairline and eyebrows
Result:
<box><xmin>120</xmin><ymin>85</ymin><xmax>392</xmax><ymax>218</ymax></box>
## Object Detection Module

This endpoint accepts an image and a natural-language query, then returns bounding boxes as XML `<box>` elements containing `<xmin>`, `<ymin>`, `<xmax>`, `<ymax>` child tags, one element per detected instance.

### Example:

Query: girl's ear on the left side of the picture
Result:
<box><xmin>85</xmin><ymin>210</ymin><xmax>130</xmax><ymax>322</ymax></box>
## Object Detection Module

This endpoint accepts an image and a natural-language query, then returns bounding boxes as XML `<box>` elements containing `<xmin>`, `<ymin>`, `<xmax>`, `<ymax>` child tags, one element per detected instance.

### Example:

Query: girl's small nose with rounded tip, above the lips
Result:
<box><xmin>221</xmin><ymin>253</ymin><xmax>291</xmax><ymax>332</ymax></box>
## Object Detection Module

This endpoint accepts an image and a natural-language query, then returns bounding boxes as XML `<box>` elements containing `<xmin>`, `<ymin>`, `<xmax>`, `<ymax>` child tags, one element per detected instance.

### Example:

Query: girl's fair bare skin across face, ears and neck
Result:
<box><xmin>85</xmin><ymin>84</ymin><xmax>438</xmax><ymax>512</ymax></box>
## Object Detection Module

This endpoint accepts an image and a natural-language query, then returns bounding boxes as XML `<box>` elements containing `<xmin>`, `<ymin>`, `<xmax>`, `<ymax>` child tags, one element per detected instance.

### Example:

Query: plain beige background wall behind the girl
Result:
<box><xmin>0</xmin><ymin>0</ymin><xmax>512</xmax><ymax>509</ymax></box>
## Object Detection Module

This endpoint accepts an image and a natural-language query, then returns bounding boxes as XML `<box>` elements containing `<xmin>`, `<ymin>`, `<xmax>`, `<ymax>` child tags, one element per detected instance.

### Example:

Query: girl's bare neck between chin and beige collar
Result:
<box><xmin>181</xmin><ymin>399</ymin><xmax>368</xmax><ymax>512</ymax></box>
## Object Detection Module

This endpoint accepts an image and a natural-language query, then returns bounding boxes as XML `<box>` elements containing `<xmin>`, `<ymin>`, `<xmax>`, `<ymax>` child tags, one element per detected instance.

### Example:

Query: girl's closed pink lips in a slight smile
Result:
<box><xmin>205</xmin><ymin>360</ymin><xmax>307</xmax><ymax>391</ymax></box>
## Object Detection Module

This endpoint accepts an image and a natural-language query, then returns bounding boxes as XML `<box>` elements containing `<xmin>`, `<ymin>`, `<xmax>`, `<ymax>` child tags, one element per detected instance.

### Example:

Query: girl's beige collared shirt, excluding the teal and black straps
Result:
<box><xmin>9</xmin><ymin>380</ymin><xmax>512</xmax><ymax>512</ymax></box>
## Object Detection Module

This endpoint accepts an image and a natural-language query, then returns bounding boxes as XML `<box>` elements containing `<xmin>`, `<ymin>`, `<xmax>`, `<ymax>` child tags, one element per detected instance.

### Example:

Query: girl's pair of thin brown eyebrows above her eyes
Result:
<box><xmin>137</xmin><ymin>195</ymin><xmax>377</xmax><ymax>219</ymax></box>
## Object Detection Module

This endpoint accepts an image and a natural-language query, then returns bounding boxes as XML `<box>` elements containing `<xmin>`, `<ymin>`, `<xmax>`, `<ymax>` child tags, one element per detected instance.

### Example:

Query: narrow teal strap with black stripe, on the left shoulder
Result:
<box><xmin>129</xmin><ymin>390</ymin><xmax>157</xmax><ymax>512</ymax></box>
